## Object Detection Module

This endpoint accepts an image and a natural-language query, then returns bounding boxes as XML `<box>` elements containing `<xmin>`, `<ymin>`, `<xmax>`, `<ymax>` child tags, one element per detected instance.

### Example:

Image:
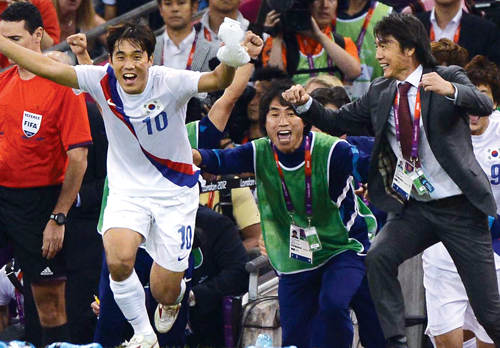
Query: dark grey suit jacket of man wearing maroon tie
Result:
<box><xmin>301</xmin><ymin>66</ymin><xmax>496</xmax><ymax>216</ymax></box>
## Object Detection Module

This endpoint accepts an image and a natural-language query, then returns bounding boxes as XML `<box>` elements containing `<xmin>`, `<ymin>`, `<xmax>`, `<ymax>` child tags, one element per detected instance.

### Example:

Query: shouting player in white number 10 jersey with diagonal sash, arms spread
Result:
<box><xmin>0</xmin><ymin>22</ymin><xmax>262</xmax><ymax>348</ymax></box>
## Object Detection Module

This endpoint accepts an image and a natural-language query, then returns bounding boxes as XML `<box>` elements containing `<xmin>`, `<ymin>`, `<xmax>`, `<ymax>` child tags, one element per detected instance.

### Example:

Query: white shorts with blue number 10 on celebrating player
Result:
<box><xmin>102</xmin><ymin>185</ymin><xmax>199</xmax><ymax>272</ymax></box>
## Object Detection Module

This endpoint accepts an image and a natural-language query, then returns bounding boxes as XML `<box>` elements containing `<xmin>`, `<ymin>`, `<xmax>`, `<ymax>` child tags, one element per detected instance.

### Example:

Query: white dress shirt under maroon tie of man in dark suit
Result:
<box><xmin>386</xmin><ymin>65</ymin><xmax>462</xmax><ymax>201</ymax></box>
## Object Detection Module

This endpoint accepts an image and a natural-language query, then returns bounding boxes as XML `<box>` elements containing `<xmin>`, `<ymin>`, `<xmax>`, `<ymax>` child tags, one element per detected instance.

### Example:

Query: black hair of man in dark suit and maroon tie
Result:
<box><xmin>373</xmin><ymin>13</ymin><xmax>437</xmax><ymax>68</ymax></box>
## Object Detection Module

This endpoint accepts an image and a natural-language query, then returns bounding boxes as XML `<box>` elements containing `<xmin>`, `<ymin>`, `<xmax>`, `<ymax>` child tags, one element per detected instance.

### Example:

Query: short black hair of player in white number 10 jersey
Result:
<box><xmin>106</xmin><ymin>20</ymin><xmax>156</xmax><ymax>60</ymax></box>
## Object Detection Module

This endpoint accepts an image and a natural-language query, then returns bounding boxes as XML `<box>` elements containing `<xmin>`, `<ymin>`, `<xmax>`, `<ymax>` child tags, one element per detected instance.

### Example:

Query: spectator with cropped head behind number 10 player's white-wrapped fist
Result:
<box><xmin>198</xmin><ymin>0</ymin><xmax>250</xmax><ymax>47</ymax></box>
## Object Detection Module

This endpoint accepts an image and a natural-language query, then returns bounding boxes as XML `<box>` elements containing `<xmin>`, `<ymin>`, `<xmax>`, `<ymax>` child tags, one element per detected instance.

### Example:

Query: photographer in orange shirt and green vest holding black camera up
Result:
<box><xmin>262</xmin><ymin>0</ymin><xmax>361</xmax><ymax>84</ymax></box>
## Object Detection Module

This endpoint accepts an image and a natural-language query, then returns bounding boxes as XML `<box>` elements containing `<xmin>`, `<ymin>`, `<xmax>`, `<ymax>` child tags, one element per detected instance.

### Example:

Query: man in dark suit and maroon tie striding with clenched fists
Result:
<box><xmin>283</xmin><ymin>14</ymin><xmax>500</xmax><ymax>348</ymax></box>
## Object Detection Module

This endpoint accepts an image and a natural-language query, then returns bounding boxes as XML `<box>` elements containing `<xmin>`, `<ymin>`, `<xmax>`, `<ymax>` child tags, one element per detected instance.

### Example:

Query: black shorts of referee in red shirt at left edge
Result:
<box><xmin>0</xmin><ymin>186</ymin><xmax>66</xmax><ymax>283</ymax></box>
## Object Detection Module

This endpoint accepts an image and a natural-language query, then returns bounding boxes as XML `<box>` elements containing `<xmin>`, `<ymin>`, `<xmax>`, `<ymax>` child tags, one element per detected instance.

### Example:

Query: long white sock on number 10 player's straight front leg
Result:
<box><xmin>109</xmin><ymin>270</ymin><xmax>154</xmax><ymax>335</ymax></box>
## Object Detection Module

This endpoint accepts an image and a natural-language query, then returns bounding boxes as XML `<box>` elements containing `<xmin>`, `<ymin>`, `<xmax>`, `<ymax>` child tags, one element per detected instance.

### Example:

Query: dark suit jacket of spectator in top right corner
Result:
<box><xmin>415</xmin><ymin>11</ymin><xmax>500</xmax><ymax>65</ymax></box>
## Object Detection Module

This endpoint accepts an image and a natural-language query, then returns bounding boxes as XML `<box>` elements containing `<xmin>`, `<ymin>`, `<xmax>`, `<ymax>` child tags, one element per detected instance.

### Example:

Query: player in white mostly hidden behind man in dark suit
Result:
<box><xmin>423</xmin><ymin>56</ymin><xmax>500</xmax><ymax>348</ymax></box>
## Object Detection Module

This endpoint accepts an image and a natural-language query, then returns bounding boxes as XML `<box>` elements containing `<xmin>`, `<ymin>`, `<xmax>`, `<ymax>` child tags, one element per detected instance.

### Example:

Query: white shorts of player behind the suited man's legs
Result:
<box><xmin>424</xmin><ymin>264</ymin><xmax>500</xmax><ymax>343</ymax></box>
